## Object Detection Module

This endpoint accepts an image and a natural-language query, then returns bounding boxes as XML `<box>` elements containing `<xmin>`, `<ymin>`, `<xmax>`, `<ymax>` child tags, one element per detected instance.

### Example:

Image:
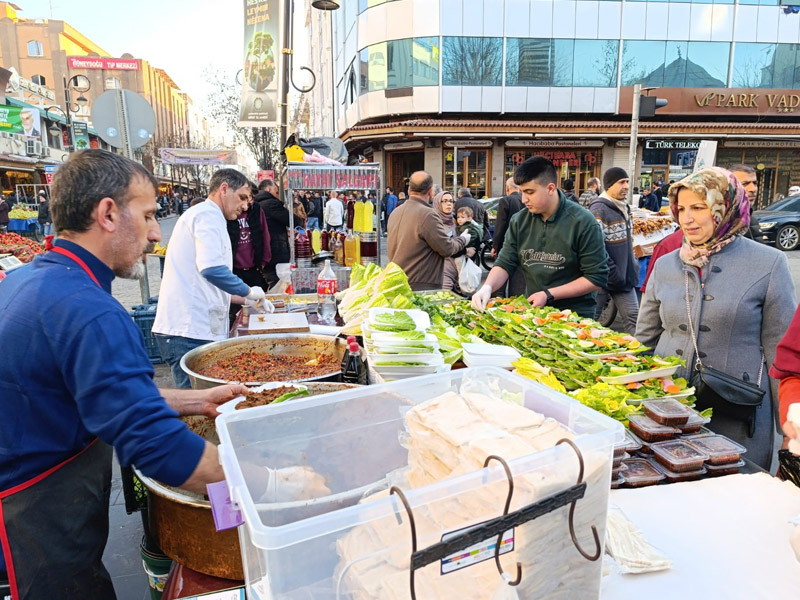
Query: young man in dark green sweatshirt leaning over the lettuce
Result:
<box><xmin>472</xmin><ymin>156</ymin><xmax>608</xmax><ymax>317</ymax></box>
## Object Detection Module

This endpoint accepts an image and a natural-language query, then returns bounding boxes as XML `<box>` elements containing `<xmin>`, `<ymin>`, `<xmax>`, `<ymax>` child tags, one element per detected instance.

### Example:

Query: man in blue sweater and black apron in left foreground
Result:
<box><xmin>0</xmin><ymin>150</ymin><xmax>245</xmax><ymax>600</ymax></box>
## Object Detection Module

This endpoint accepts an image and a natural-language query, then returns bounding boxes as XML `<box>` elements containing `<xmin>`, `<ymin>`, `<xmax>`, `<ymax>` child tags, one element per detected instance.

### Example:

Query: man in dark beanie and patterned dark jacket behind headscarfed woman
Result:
<box><xmin>589</xmin><ymin>167</ymin><xmax>639</xmax><ymax>335</ymax></box>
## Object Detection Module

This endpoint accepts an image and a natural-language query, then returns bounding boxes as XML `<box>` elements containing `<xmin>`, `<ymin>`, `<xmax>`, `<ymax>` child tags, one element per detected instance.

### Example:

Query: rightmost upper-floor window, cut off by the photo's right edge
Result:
<box><xmin>731</xmin><ymin>43</ymin><xmax>800</xmax><ymax>88</ymax></box>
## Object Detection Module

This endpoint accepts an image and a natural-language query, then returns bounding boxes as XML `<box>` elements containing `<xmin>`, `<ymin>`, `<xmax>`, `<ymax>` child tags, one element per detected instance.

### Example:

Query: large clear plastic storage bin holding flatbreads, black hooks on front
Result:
<box><xmin>216</xmin><ymin>368</ymin><xmax>624</xmax><ymax>600</ymax></box>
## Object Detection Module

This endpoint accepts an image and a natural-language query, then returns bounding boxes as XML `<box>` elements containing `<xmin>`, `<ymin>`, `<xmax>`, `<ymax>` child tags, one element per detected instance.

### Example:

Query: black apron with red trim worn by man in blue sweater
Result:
<box><xmin>0</xmin><ymin>247</ymin><xmax>116</xmax><ymax>600</ymax></box>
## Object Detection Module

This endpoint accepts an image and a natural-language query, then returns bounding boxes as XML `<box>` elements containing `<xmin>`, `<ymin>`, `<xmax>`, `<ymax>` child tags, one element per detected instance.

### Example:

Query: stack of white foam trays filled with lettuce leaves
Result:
<box><xmin>361</xmin><ymin>308</ymin><xmax>450</xmax><ymax>381</ymax></box>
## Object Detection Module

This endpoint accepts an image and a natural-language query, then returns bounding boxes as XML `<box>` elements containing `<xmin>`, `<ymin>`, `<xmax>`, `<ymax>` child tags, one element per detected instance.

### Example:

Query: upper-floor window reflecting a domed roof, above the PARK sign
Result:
<box><xmin>622</xmin><ymin>40</ymin><xmax>730</xmax><ymax>87</ymax></box>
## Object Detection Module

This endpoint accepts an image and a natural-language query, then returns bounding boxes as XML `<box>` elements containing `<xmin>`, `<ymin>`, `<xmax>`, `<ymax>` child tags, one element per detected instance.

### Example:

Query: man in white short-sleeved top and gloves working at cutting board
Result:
<box><xmin>153</xmin><ymin>169</ymin><xmax>271</xmax><ymax>389</ymax></box>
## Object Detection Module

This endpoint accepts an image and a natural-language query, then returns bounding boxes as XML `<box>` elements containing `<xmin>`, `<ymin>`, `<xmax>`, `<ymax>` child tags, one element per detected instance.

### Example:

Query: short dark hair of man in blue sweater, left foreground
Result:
<box><xmin>50</xmin><ymin>149</ymin><xmax>158</xmax><ymax>233</ymax></box>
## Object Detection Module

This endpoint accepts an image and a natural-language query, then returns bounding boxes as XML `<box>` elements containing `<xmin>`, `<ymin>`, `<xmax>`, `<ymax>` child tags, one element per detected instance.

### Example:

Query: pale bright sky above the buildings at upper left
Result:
<box><xmin>14</xmin><ymin>0</ymin><xmax>305</xmax><ymax>113</ymax></box>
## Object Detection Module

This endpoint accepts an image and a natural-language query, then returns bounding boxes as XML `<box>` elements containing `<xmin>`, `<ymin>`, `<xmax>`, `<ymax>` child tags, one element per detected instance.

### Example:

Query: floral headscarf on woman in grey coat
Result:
<box><xmin>669</xmin><ymin>167</ymin><xmax>750</xmax><ymax>267</ymax></box>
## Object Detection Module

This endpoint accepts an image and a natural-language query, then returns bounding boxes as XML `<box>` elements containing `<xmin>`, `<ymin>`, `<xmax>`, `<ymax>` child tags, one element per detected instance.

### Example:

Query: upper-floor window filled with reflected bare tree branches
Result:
<box><xmin>442</xmin><ymin>37</ymin><xmax>503</xmax><ymax>86</ymax></box>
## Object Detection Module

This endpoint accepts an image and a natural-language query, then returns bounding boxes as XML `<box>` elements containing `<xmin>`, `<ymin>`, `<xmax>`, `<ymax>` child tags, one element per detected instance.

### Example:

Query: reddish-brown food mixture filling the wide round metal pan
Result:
<box><xmin>199</xmin><ymin>352</ymin><xmax>340</xmax><ymax>382</ymax></box>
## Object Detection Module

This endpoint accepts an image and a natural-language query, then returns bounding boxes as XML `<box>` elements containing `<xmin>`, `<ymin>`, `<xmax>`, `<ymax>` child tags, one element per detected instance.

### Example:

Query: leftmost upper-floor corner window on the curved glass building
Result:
<box><xmin>359</xmin><ymin>37</ymin><xmax>439</xmax><ymax>94</ymax></box>
